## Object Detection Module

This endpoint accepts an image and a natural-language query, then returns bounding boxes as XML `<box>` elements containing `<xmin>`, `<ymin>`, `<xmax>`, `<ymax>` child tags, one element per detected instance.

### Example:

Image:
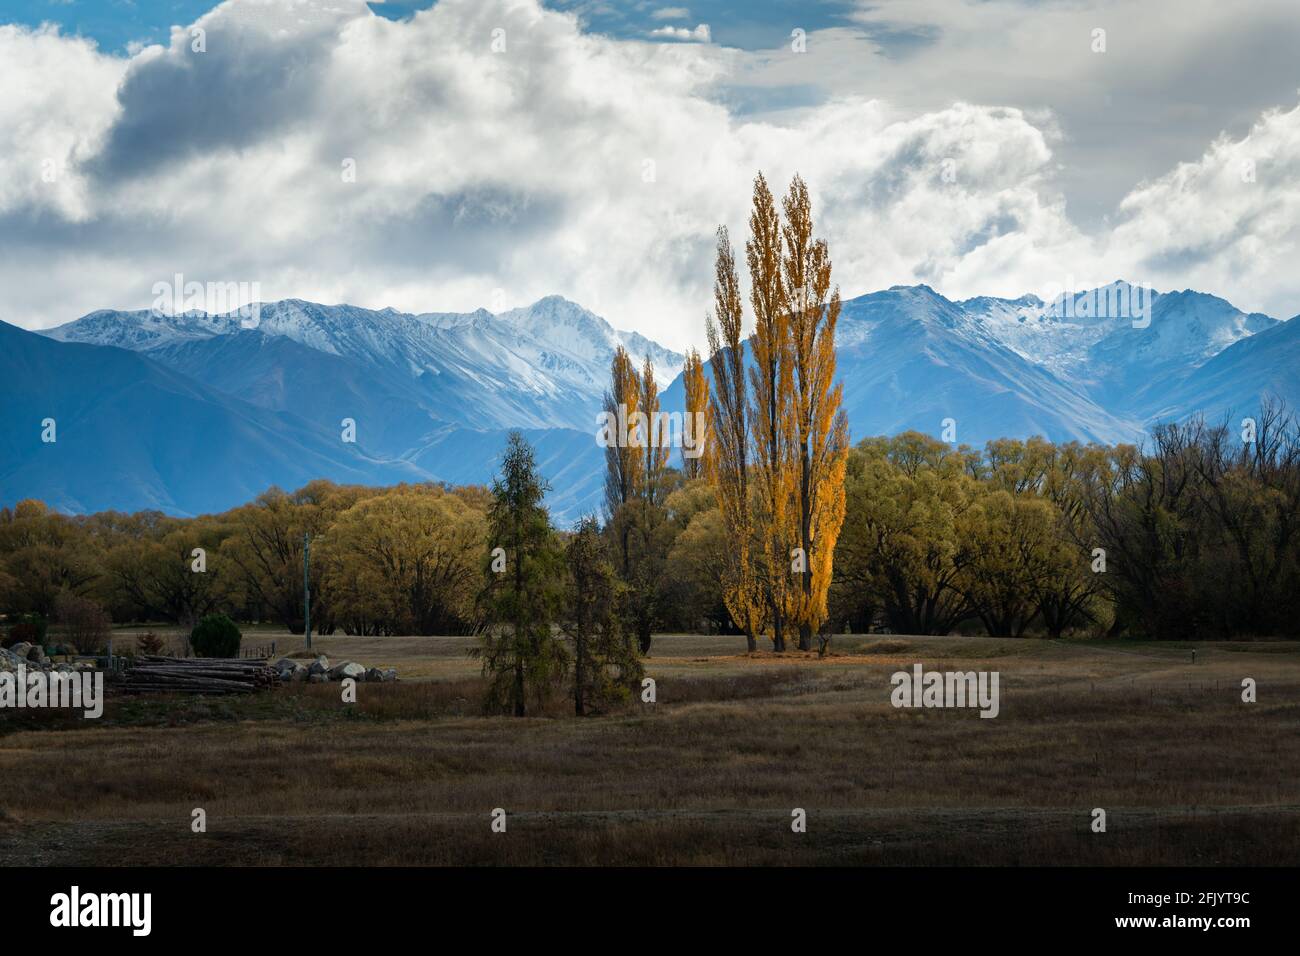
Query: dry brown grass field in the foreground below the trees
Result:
<box><xmin>0</xmin><ymin>633</ymin><xmax>1300</xmax><ymax>866</ymax></box>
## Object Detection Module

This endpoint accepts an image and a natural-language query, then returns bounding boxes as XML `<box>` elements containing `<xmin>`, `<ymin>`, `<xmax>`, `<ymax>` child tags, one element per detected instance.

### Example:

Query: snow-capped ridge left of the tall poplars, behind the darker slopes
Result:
<box><xmin>44</xmin><ymin>295</ymin><xmax>683</xmax><ymax>431</ymax></box>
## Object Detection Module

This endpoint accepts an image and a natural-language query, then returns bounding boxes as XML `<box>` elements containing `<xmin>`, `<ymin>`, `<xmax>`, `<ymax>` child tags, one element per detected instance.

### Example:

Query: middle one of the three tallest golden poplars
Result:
<box><xmin>745</xmin><ymin>173</ymin><xmax>798</xmax><ymax>652</ymax></box>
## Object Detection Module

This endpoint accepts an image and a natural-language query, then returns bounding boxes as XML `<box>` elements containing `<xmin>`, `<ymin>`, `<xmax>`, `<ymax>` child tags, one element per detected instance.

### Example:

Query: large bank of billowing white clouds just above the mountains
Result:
<box><xmin>0</xmin><ymin>0</ymin><xmax>1300</xmax><ymax>346</ymax></box>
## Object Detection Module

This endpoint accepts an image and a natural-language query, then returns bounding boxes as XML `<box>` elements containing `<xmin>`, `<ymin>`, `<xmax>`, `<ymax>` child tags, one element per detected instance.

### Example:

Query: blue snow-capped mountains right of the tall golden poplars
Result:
<box><xmin>664</xmin><ymin>282</ymin><xmax>1300</xmax><ymax>445</ymax></box>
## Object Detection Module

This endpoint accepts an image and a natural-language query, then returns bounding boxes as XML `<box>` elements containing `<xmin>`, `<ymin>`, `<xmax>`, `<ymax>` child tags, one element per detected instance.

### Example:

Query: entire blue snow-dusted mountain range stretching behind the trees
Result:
<box><xmin>0</xmin><ymin>284</ymin><xmax>1300</xmax><ymax>522</ymax></box>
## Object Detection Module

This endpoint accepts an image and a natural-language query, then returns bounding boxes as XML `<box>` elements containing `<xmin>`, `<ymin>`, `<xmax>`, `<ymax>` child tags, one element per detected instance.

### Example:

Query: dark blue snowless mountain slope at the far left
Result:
<box><xmin>0</xmin><ymin>323</ymin><xmax>425</xmax><ymax>515</ymax></box>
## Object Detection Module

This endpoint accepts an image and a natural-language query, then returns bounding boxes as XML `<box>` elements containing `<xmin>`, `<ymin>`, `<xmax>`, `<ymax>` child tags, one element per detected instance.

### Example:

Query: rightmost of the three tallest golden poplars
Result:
<box><xmin>781</xmin><ymin>176</ymin><xmax>849</xmax><ymax>650</ymax></box>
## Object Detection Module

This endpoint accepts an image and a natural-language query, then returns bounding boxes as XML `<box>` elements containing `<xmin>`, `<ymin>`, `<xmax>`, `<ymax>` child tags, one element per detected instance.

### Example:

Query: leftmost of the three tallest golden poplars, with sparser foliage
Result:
<box><xmin>705</xmin><ymin>226</ymin><xmax>763</xmax><ymax>652</ymax></box>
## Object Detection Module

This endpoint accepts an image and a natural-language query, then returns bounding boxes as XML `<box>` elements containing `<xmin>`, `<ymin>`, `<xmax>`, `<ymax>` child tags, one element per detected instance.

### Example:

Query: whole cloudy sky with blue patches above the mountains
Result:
<box><xmin>0</xmin><ymin>0</ymin><xmax>1300</xmax><ymax>349</ymax></box>
